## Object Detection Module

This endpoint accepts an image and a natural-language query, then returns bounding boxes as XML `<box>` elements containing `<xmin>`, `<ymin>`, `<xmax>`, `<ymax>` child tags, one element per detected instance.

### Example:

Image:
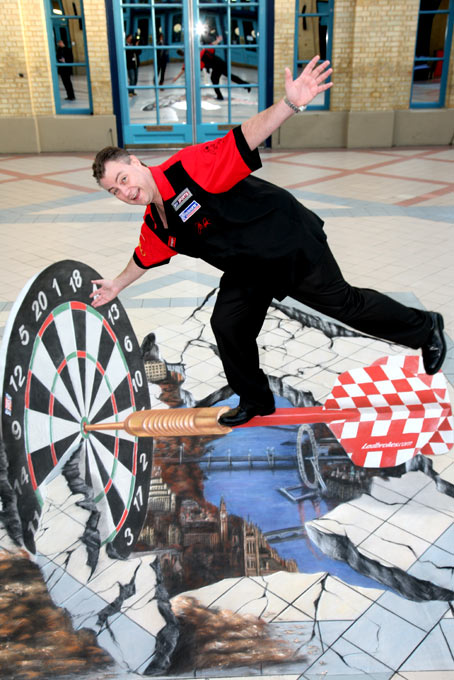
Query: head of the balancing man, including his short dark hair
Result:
<box><xmin>93</xmin><ymin>146</ymin><xmax>159</xmax><ymax>205</ymax></box>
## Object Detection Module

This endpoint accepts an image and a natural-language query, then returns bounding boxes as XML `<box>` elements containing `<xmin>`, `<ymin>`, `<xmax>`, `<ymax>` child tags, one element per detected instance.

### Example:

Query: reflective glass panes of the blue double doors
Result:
<box><xmin>122</xmin><ymin>2</ymin><xmax>260</xmax><ymax>126</ymax></box>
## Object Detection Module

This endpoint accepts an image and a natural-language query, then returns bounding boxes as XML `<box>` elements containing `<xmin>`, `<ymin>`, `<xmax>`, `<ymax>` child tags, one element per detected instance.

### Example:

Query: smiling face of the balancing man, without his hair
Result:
<box><xmin>100</xmin><ymin>156</ymin><xmax>160</xmax><ymax>205</ymax></box>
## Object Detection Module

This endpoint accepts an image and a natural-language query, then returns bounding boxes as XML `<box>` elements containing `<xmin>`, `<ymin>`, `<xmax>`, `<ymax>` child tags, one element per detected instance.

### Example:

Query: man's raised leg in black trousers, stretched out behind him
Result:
<box><xmin>289</xmin><ymin>248</ymin><xmax>445</xmax><ymax>372</ymax></box>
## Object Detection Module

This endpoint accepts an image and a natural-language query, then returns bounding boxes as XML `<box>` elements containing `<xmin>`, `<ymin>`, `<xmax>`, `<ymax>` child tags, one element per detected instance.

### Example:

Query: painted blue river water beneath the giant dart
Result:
<box><xmin>203</xmin><ymin>397</ymin><xmax>387</xmax><ymax>590</ymax></box>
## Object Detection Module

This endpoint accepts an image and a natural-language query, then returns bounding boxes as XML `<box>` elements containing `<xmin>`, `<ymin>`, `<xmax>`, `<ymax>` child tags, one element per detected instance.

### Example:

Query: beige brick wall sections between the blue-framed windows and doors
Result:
<box><xmin>0</xmin><ymin>0</ymin><xmax>454</xmax><ymax>146</ymax></box>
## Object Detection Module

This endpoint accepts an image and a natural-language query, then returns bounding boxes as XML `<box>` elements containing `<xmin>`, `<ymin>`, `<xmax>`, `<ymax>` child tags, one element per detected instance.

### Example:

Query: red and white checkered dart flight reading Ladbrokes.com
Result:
<box><xmin>325</xmin><ymin>356</ymin><xmax>454</xmax><ymax>467</ymax></box>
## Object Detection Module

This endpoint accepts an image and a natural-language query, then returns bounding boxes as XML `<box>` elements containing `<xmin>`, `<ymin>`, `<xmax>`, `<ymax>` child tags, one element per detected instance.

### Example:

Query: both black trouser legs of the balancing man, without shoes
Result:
<box><xmin>211</xmin><ymin>247</ymin><xmax>431</xmax><ymax>407</ymax></box>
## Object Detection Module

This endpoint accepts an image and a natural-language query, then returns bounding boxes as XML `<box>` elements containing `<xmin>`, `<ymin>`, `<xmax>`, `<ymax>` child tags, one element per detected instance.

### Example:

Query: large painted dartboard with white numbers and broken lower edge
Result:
<box><xmin>0</xmin><ymin>260</ymin><xmax>152</xmax><ymax>556</ymax></box>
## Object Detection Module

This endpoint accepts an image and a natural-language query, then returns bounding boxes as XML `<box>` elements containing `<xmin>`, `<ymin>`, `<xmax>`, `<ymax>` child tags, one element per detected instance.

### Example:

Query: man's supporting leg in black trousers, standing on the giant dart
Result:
<box><xmin>211</xmin><ymin>274</ymin><xmax>274</xmax><ymax>419</ymax></box>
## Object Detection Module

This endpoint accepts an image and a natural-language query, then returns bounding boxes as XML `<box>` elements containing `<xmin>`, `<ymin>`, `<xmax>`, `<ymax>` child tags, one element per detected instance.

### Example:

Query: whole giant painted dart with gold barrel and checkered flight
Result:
<box><xmin>84</xmin><ymin>356</ymin><xmax>454</xmax><ymax>468</ymax></box>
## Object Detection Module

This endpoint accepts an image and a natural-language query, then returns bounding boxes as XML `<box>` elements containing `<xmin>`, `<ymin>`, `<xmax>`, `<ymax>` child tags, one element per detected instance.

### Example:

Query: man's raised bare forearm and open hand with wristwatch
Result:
<box><xmin>241</xmin><ymin>56</ymin><xmax>333</xmax><ymax>150</ymax></box>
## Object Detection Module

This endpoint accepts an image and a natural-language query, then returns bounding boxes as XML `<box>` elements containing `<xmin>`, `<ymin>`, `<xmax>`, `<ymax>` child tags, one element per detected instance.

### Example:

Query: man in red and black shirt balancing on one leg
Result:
<box><xmin>91</xmin><ymin>57</ymin><xmax>446</xmax><ymax>426</ymax></box>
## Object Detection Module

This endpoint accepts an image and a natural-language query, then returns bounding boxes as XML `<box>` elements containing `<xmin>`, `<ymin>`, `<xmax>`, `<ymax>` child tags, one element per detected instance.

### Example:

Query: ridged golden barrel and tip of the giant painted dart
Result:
<box><xmin>84</xmin><ymin>406</ymin><xmax>232</xmax><ymax>437</ymax></box>
